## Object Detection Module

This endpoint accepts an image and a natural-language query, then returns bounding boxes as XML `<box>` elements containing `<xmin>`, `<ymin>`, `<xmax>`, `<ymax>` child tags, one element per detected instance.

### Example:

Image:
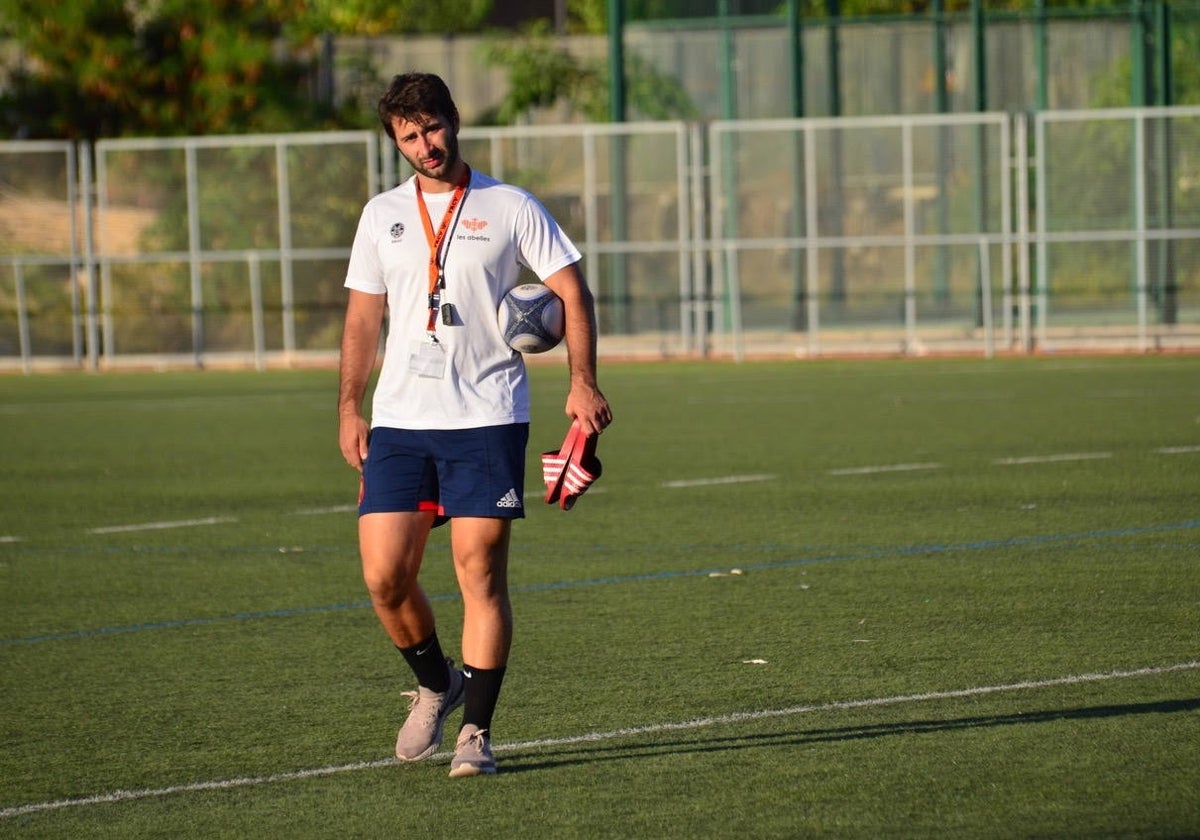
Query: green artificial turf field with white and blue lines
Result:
<box><xmin>0</xmin><ymin>356</ymin><xmax>1200</xmax><ymax>840</ymax></box>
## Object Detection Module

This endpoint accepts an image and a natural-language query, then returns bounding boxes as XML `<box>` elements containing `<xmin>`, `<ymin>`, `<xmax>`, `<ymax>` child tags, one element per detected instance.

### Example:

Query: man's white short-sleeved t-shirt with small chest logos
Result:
<box><xmin>346</xmin><ymin>172</ymin><xmax>580</xmax><ymax>430</ymax></box>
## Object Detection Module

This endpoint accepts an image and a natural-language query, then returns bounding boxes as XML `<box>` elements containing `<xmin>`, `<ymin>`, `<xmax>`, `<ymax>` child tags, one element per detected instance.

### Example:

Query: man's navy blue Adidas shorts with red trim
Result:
<box><xmin>359</xmin><ymin>422</ymin><xmax>529</xmax><ymax>523</ymax></box>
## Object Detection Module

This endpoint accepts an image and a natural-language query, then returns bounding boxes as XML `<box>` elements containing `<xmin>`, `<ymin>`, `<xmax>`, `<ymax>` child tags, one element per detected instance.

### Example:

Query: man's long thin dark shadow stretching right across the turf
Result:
<box><xmin>503</xmin><ymin>697</ymin><xmax>1200</xmax><ymax>774</ymax></box>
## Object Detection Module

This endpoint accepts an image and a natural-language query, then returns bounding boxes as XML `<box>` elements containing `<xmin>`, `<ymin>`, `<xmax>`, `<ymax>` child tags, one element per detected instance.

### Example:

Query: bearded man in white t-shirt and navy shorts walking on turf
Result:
<box><xmin>338</xmin><ymin>73</ymin><xmax>612</xmax><ymax>778</ymax></box>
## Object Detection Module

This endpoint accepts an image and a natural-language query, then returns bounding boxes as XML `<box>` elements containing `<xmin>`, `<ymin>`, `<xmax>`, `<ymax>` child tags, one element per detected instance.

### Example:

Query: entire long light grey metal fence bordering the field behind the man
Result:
<box><xmin>0</xmin><ymin>108</ymin><xmax>1200</xmax><ymax>371</ymax></box>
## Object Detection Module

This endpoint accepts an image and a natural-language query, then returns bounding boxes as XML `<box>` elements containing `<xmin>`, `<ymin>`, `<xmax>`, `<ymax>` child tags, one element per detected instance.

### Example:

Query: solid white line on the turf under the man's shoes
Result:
<box><xmin>0</xmin><ymin>660</ymin><xmax>1200</xmax><ymax>818</ymax></box>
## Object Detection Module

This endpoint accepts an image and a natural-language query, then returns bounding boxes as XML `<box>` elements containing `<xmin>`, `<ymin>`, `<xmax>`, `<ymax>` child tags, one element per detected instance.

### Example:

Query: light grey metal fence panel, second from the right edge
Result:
<box><xmin>709</xmin><ymin>114</ymin><xmax>1013</xmax><ymax>355</ymax></box>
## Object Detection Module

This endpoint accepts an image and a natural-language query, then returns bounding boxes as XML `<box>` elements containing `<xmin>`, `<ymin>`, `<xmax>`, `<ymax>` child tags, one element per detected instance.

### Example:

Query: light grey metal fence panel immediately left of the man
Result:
<box><xmin>88</xmin><ymin>132</ymin><xmax>379</xmax><ymax>365</ymax></box>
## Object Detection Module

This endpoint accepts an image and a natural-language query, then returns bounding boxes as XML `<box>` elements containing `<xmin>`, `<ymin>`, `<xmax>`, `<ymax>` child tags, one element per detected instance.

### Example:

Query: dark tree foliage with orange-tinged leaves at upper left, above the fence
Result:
<box><xmin>0</xmin><ymin>0</ymin><xmax>492</xmax><ymax>139</ymax></box>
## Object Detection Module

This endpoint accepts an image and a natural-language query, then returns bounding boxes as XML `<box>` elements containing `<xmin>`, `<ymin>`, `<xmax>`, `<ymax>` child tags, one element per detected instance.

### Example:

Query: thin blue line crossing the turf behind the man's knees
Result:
<box><xmin>0</xmin><ymin>520</ymin><xmax>1200</xmax><ymax>647</ymax></box>
